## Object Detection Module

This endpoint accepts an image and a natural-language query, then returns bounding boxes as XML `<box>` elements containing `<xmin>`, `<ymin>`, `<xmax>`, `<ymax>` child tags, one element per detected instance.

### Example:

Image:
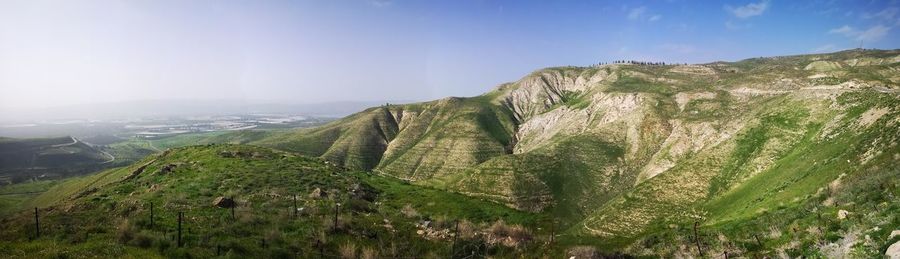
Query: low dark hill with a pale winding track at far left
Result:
<box><xmin>0</xmin><ymin>136</ymin><xmax>115</xmax><ymax>184</ymax></box>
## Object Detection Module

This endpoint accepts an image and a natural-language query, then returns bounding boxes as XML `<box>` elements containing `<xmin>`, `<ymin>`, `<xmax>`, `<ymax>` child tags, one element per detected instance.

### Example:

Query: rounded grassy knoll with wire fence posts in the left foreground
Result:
<box><xmin>0</xmin><ymin>145</ymin><xmax>552</xmax><ymax>257</ymax></box>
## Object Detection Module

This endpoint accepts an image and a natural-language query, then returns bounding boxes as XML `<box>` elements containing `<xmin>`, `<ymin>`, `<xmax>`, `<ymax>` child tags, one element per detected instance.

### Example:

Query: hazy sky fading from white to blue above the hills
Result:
<box><xmin>0</xmin><ymin>0</ymin><xmax>900</xmax><ymax>109</ymax></box>
